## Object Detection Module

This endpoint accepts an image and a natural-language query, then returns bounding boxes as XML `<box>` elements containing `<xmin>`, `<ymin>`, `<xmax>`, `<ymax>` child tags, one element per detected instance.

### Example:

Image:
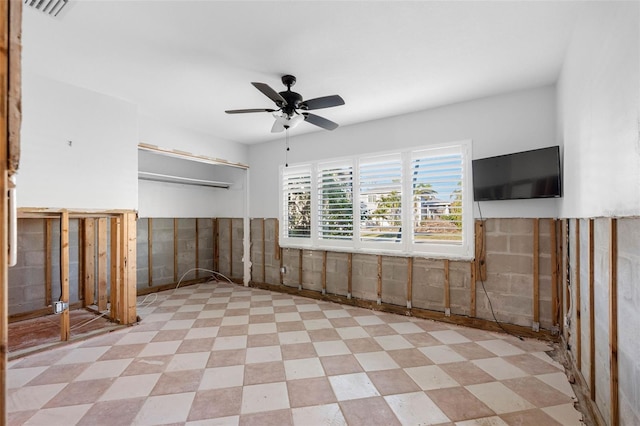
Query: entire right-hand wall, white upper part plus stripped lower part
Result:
<box><xmin>558</xmin><ymin>2</ymin><xmax>640</xmax><ymax>425</ymax></box>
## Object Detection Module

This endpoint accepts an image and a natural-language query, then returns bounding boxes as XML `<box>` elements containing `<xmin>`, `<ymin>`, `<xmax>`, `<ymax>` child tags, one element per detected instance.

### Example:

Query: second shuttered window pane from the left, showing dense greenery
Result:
<box><xmin>318</xmin><ymin>165</ymin><xmax>353</xmax><ymax>240</ymax></box>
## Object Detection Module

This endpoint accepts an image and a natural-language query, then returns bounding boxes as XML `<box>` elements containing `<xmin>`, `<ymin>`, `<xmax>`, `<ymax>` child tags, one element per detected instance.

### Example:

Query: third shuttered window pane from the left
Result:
<box><xmin>359</xmin><ymin>155</ymin><xmax>402</xmax><ymax>242</ymax></box>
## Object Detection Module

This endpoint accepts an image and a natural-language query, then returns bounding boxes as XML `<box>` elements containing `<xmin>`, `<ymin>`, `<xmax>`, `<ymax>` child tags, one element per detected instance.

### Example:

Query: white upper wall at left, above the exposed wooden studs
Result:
<box><xmin>17</xmin><ymin>71</ymin><xmax>138</xmax><ymax>210</ymax></box>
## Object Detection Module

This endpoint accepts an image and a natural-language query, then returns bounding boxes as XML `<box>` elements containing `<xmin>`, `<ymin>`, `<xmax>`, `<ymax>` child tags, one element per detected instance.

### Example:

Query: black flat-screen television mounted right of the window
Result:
<box><xmin>471</xmin><ymin>146</ymin><xmax>562</xmax><ymax>201</ymax></box>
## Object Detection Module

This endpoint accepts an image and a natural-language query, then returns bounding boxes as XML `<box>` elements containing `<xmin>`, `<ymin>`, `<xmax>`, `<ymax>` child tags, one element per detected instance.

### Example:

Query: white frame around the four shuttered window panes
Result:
<box><xmin>279</xmin><ymin>140</ymin><xmax>475</xmax><ymax>260</ymax></box>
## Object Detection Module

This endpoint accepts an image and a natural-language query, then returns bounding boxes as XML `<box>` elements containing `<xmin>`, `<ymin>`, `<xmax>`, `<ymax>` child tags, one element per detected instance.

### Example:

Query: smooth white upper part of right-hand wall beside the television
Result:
<box><xmin>558</xmin><ymin>2</ymin><xmax>640</xmax><ymax>217</ymax></box>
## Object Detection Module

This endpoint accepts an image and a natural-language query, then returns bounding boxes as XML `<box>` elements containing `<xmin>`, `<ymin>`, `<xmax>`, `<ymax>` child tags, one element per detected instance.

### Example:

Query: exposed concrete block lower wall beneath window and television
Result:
<box><xmin>251</xmin><ymin>219</ymin><xmax>554</xmax><ymax>330</ymax></box>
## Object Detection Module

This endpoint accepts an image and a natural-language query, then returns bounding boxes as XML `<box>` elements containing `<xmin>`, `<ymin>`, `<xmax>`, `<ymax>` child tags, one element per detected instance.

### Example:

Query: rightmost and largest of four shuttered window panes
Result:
<box><xmin>411</xmin><ymin>150</ymin><xmax>463</xmax><ymax>244</ymax></box>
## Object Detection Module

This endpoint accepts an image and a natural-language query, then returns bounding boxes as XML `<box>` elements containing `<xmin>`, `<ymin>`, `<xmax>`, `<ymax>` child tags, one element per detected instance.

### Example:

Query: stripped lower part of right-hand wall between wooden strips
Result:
<box><xmin>564</xmin><ymin>218</ymin><xmax>640</xmax><ymax>425</ymax></box>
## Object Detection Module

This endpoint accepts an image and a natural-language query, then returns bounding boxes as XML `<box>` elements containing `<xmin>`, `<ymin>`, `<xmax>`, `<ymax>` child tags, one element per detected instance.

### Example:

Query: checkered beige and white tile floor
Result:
<box><xmin>7</xmin><ymin>282</ymin><xmax>581</xmax><ymax>426</ymax></box>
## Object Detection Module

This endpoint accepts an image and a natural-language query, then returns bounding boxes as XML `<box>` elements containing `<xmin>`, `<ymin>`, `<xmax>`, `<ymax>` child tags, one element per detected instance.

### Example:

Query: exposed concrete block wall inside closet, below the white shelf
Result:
<box><xmin>136</xmin><ymin>218</ymin><xmax>221</xmax><ymax>290</ymax></box>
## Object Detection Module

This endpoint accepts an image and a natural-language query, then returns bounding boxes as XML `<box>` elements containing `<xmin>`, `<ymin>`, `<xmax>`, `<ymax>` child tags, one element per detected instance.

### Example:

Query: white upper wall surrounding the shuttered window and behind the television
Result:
<box><xmin>249</xmin><ymin>86</ymin><xmax>558</xmax><ymax>217</ymax></box>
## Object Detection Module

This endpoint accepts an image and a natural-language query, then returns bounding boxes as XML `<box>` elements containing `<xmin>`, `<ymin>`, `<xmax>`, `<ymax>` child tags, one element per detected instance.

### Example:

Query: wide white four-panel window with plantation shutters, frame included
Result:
<box><xmin>280</xmin><ymin>142</ymin><xmax>474</xmax><ymax>259</ymax></box>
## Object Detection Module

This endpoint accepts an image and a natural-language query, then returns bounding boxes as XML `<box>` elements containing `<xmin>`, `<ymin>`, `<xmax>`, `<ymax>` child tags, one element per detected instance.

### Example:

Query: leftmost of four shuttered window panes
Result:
<box><xmin>282</xmin><ymin>167</ymin><xmax>311</xmax><ymax>238</ymax></box>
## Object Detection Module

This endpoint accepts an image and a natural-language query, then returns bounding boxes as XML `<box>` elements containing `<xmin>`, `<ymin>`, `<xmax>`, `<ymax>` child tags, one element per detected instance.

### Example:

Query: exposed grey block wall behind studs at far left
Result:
<box><xmin>8</xmin><ymin>219</ymin><xmax>80</xmax><ymax>315</ymax></box>
